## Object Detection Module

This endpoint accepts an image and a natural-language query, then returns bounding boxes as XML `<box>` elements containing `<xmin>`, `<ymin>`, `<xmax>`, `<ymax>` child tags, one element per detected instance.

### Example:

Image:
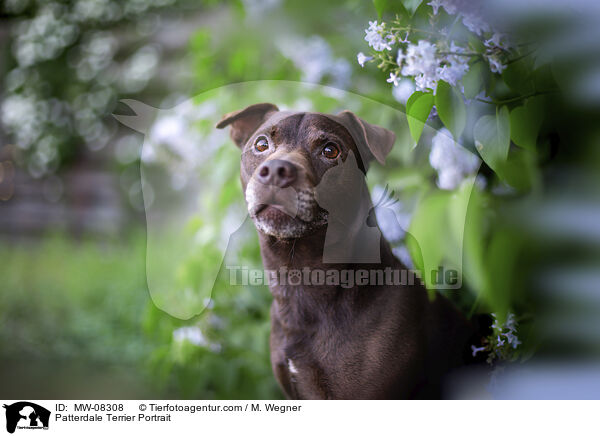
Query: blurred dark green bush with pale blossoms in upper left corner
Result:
<box><xmin>0</xmin><ymin>0</ymin><xmax>224</xmax><ymax>178</ymax></box>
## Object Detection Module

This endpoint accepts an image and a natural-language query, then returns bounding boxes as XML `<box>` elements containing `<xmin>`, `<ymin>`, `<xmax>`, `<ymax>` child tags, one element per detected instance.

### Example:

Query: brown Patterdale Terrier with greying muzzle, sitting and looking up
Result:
<box><xmin>217</xmin><ymin>103</ymin><xmax>473</xmax><ymax>399</ymax></box>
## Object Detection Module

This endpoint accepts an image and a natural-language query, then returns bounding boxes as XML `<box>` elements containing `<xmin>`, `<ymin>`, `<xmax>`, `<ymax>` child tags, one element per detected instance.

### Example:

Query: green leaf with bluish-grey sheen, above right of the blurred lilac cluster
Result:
<box><xmin>473</xmin><ymin>106</ymin><xmax>510</xmax><ymax>173</ymax></box>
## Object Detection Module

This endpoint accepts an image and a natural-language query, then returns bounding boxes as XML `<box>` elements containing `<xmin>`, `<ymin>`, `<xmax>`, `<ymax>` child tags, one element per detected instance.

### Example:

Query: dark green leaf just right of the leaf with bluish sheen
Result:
<box><xmin>510</xmin><ymin>97</ymin><xmax>544</xmax><ymax>151</ymax></box>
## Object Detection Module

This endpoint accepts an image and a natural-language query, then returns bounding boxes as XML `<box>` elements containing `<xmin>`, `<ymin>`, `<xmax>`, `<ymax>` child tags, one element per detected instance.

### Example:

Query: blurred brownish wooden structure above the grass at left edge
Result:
<box><xmin>0</xmin><ymin>147</ymin><xmax>132</xmax><ymax>239</ymax></box>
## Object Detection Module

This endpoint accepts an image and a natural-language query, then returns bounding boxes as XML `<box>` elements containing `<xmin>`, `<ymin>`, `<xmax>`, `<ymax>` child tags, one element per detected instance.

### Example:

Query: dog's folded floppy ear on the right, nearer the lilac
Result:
<box><xmin>335</xmin><ymin>111</ymin><xmax>396</xmax><ymax>164</ymax></box>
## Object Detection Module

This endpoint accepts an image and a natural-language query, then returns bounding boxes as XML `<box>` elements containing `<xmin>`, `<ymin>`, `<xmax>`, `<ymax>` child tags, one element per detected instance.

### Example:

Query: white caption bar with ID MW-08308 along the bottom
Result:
<box><xmin>2</xmin><ymin>400</ymin><xmax>600</xmax><ymax>436</ymax></box>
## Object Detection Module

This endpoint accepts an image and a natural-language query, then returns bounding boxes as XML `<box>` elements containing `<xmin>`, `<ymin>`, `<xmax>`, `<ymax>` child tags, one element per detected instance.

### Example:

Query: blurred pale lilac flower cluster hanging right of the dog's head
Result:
<box><xmin>429</xmin><ymin>128</ymin><xmax>481</xmax><ymax>190</ymax></box>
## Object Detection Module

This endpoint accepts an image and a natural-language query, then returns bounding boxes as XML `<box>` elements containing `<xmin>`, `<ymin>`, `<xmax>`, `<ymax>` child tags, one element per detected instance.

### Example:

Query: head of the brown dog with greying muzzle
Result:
<box><xmin>217</xmin><ymin>103</ymin><xmax>395</xmax><ymax>239</ymax></box>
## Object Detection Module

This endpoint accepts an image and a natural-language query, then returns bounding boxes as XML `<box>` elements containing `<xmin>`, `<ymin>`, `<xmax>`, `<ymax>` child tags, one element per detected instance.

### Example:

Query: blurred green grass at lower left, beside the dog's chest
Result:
<box><xmin>0</xmin><ymin>233</ymin><xmax>280</xmax><ymax>399</ymax></box>
